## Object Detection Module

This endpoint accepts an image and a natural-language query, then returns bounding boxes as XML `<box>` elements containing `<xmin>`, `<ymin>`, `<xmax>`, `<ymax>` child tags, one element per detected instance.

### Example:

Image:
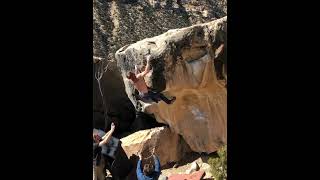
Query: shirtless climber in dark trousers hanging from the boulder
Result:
<box><xmin>126</xmin><ymin>55</ymin><xmax>176</xmax><ymax>104</ymax></box>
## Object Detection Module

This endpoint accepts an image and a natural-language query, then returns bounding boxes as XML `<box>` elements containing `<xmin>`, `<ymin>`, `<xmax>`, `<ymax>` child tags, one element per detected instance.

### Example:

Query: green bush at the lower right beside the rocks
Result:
<box><xmin>208</xmin><ymin>145</ymin><xmax>227</xmax><ymax>180</ymax></box>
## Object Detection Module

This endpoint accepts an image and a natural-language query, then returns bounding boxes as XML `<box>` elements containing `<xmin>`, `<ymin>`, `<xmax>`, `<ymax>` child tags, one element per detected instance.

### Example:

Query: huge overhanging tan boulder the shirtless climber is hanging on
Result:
<box><xmin>116</xmin><ymin>17</ymin><xmax>227</xmax><ymax>153</ymax></box>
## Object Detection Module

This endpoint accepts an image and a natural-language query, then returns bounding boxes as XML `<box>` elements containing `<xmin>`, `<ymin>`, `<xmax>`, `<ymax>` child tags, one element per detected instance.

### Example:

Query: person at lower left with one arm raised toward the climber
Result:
<box><xmin>93</xmin><ymin>124</ymin><xmax>115</xmax><ymax>180</ymax></box>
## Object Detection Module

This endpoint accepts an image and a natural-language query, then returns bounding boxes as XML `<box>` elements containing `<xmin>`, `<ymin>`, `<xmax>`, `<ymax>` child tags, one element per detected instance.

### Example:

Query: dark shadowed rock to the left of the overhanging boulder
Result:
<box><xmin>93</xmin><ymin>62</ymin><xmax>135</xmax><ymax>134</ymax></box>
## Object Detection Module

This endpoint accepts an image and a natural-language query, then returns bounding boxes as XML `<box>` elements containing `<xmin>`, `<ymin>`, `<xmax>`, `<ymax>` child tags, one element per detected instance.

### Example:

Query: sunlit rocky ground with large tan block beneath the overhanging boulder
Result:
<box><xmin>117</xmin><ymin>127</ymin><xmax>222</xmax><ymax>180</ymax></box>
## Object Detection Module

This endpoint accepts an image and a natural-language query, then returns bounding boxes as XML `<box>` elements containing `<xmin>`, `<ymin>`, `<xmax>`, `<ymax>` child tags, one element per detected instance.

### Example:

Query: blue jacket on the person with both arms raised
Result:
<box><xmin>136</xmin><ymin>156</ymin><xmax>161</xmax><ymax>180</ymax></box>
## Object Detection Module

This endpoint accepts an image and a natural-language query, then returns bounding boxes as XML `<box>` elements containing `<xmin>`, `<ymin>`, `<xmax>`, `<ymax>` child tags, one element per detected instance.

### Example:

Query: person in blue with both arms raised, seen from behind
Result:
<box><xmin>136</xmin><ymin>154</ymin><xmax>161</xmax><ymax>180</ymax></box>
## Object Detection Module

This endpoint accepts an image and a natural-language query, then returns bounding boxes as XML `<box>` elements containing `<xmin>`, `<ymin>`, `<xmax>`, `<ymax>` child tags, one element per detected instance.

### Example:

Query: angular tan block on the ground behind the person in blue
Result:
<box><xmin>121</xmin><ymin>127</ymin><xmax>190</xmax><ymax>166</ymax></box>
